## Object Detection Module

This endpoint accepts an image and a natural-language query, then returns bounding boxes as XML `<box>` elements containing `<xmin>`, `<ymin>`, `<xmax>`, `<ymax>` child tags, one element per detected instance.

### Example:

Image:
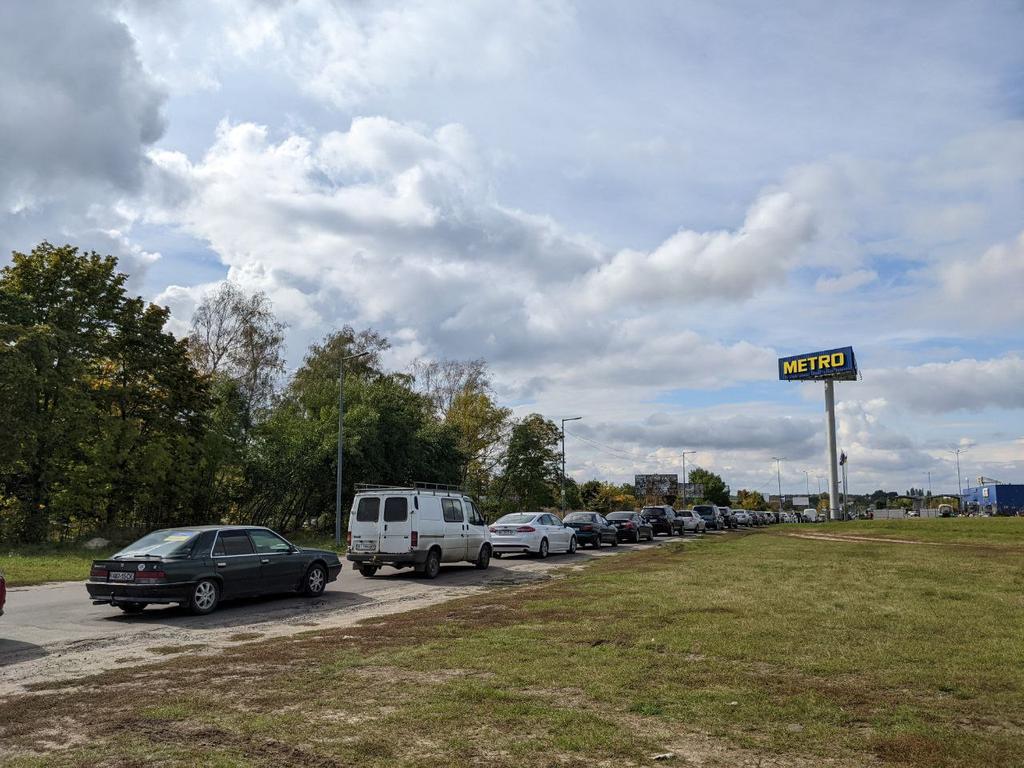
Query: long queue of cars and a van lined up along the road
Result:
<box><xmin>75</xmin><ymin>484</ymin><xmax>819</xmax><ymax>614</ymax></box>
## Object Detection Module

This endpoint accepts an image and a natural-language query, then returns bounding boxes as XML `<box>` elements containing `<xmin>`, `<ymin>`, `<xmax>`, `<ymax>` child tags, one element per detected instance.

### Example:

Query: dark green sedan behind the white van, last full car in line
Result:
<box><xmin>85</xmin><ymin>525</ymin><xmax>341</xmax><ymax>614</ymax></box>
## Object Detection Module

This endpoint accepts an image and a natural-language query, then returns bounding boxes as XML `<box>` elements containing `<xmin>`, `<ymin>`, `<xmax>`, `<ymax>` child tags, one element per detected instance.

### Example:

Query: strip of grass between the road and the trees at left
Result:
<box><xmin>0</xmin><ymin>534</ymin><xmax>345</xmax><ymax>587</ymax></box>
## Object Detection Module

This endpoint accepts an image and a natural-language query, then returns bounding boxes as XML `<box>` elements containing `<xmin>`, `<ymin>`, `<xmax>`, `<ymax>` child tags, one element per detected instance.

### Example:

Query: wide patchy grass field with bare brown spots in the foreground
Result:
<box><xmin>0</xmin><ymin>519</ymin><xmax>1024</xmax><ymax>768</ymax></box>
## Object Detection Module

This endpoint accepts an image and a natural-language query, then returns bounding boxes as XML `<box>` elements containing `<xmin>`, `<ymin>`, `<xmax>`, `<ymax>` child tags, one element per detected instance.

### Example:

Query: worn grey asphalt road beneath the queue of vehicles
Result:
<box><xmin>0</xmin><ymin>537</ymin><xmax>704</xmax><ymax>697</ymax></box>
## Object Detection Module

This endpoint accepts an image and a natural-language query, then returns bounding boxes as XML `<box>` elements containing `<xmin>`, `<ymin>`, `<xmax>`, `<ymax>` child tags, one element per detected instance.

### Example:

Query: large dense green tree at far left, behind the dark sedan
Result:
<box><xmin>0</xmin><ymin>243</ymin><xmax>210</xmax><ymax>542</ymax></box>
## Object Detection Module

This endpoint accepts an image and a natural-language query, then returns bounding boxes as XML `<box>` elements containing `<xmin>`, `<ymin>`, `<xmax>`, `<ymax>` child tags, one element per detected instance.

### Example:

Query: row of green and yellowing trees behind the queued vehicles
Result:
<box><xmin>0</xmin><ymin>243</ymin><xmax>663</xmax><ymax>543</ymax></box>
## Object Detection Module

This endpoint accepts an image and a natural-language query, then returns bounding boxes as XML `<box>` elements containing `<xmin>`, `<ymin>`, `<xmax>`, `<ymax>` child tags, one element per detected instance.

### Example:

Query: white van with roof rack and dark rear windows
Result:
<box><xmin>346</xmin><ymin>483</ymin><xmax>492</xmax><ymax>579</ymax></box>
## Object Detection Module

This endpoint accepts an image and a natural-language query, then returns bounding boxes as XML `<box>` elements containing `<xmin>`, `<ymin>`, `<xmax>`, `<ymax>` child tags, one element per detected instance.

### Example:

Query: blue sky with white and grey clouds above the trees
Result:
<box><xmin>0</xmin><ymin>0</ymin><xmax>1024</xmax><ymax>494</ymax></box>
